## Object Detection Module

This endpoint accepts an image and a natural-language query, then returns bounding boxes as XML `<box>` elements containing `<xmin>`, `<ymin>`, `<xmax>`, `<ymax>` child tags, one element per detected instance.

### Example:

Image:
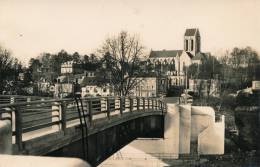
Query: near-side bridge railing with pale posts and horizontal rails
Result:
<box><xmin>0</xmin><ymin>97</ymin><xmax>166</xmax><ymax>149</ymax></box>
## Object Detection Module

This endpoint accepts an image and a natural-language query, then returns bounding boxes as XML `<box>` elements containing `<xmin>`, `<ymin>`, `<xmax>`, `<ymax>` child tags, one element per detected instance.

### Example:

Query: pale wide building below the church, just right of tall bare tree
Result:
<box><xmin>132</xmin><ymin>77</ymin><xmax>168</xmax><ymax>97</ymax></box>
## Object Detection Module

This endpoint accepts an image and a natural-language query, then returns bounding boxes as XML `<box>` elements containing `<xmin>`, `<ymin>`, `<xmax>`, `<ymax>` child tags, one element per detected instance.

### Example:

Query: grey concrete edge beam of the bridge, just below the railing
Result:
<box><xmin>23</xmin><ymin>110</ymin><xmax>164</xmax><ymax>155</ymax></box>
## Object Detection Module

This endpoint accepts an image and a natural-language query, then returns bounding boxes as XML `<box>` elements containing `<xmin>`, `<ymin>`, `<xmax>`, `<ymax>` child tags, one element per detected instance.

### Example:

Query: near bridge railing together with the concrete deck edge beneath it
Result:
<box><xmin>0</xmin><ymin>97</ymin><xmax>165</xmax><ymax>155</ymax></box>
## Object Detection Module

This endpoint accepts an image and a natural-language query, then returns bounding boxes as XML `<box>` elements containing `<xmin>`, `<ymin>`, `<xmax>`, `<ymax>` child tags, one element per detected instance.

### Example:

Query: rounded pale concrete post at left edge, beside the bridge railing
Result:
<box><xmin>0</xmin><ymin>120</ymin><xmax>12</xmax><ymax>154</ymax></box>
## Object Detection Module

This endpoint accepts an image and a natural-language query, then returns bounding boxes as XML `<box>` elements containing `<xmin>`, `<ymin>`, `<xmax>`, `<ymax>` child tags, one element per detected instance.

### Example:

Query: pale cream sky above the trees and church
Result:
<box><xmin>0</xmin><ymin>0</ymin><xmax>260</xmax><ymax>63</ymax></box>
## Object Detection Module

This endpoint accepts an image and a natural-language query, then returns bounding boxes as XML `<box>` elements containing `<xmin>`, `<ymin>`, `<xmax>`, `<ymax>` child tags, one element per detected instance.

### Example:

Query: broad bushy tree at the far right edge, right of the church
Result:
<box><xmin>220</xmin><ymin>47</ymin><xmax>259</xmax><ymax>91</ymax></box>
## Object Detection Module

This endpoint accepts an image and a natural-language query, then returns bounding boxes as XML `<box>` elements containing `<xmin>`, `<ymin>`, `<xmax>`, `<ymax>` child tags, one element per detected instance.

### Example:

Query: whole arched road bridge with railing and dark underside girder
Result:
<box><xmin>0</xmin><ymin>97</ymin><xmax>166</xmax><ymax>166</ymax></box>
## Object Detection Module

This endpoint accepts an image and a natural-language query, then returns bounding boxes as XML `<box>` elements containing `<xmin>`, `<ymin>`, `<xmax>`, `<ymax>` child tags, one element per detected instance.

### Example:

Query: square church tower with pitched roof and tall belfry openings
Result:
<box><xmin>184</xmin><ymin>28</ymin><xmax>200</xmax><ymax>56</ymax></box>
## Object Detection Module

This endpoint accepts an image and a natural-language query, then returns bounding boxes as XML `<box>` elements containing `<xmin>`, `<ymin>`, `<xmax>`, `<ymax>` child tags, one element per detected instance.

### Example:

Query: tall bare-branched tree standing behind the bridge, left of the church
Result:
<box><xmin>99</xmin><ymin>31</ymin><xmax>144</xmax><ymax>96</ymax></box>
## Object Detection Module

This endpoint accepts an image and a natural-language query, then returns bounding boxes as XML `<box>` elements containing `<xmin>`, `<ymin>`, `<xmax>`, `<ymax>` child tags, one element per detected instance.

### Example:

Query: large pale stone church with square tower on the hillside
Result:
<box><xmin>148</xmin><ymin>28</ymin><xmax>209</xmax><ymax>86</ymax></box>
